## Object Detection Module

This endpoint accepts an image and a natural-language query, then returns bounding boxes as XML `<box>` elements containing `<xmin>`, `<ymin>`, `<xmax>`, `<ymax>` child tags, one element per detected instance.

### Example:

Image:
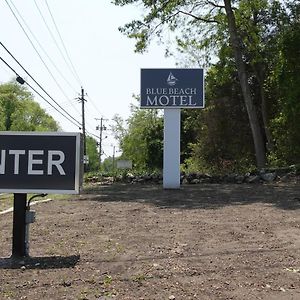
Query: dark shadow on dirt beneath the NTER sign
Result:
<box><xmin>0</xmin><ymin>255</ymin><xmax>80</xmax><ymax>270</ymax></box>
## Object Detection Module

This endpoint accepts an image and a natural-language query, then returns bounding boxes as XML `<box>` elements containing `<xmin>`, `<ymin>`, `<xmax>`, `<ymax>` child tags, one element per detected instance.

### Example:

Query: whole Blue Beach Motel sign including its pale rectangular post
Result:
<box><xmin>141</xmin><ymin>69</ymin><xmax>204</xmax><ymax>189</ymax></box>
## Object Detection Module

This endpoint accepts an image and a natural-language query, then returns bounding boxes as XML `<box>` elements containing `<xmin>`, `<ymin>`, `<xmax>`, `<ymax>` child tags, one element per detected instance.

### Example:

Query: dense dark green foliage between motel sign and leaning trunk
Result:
<box><xmin>183</xmin><ymin>61</ymin><xmax>255</xmax><ymax>173</ymax></box>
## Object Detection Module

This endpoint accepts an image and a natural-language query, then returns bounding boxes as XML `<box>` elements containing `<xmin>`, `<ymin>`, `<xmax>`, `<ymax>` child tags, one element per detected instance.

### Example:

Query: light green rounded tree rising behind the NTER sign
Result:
<box><xmin>0</xmin><ymin>83</ymin><xmax>59</xmax><ymax>131</ymax></box>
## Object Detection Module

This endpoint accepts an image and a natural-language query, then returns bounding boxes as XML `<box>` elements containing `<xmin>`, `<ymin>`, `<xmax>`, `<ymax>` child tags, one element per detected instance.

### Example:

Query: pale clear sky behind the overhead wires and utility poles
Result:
<box><xmin>0</xmin><ymin>0</ymin><xmax>176</xmax><ymax>160</ymax></box>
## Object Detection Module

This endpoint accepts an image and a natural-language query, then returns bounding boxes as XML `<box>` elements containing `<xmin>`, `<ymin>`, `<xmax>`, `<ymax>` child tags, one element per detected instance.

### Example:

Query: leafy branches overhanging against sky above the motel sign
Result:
<box><xmin>113</xmin><ymin>0</ymin><xmax>222</xmax><ymax>53</ymax></box>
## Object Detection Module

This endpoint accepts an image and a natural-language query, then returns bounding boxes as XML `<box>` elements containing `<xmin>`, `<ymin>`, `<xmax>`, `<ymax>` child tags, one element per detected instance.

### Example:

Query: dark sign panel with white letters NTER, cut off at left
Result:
<box><xmin>0</xmin><ymin>131</ymin><xmax>81</xmax><ymax>194</ymax></box>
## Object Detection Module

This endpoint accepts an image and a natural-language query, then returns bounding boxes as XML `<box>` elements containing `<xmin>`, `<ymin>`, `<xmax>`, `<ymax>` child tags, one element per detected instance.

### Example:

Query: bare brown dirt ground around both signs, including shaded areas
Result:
<box><xmin>0</xmin><ymin>184</ymin><xmax>300</xmax><ymax>300</ymax></box>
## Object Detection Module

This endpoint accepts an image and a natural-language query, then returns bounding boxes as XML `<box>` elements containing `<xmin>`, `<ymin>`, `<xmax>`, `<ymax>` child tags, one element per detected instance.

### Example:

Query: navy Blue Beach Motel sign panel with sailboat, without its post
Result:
<box><xmin>141</xmin><ymin>69</ymin><xmax>204</xmax><ymax>108</ymax></box>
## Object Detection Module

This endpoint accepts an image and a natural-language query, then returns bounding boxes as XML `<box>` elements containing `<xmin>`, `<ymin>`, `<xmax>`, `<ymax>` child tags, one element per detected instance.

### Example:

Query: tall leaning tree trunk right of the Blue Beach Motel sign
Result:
<box><xmin>224</xmin><ymin>0</ymin><xmax>266</xmax><ymax>168</ymax></box>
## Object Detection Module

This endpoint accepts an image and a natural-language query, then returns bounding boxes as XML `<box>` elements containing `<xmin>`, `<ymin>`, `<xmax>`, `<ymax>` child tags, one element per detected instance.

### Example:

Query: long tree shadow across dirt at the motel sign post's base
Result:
<box><xmin>79</xmin><ymin>184</ymin><xmax>300</xmax><ymax>210</ymax></box>
